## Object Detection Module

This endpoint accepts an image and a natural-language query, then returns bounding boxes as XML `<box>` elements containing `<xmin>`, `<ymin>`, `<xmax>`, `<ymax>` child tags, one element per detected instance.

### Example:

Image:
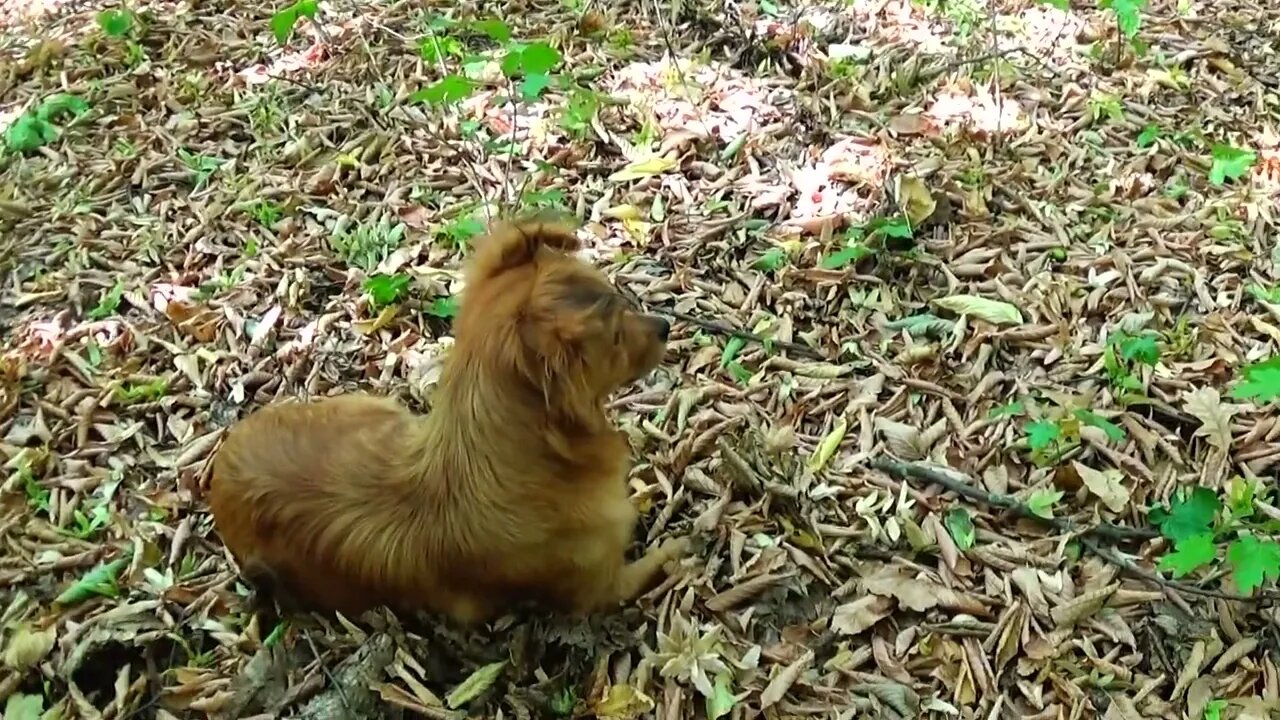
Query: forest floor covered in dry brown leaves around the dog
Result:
<box><xmin>0</xmin><ymin>0</ymin><xmax>1280</xmax><ymax>720</ymax></box>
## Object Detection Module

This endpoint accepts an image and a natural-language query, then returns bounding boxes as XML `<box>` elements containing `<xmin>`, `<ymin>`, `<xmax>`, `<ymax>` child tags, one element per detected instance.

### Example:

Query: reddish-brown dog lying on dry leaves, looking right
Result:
<box><xmin>209</xmin><ymin>215</ymin><xmax>687</xmax><ymax>623</ymax></box>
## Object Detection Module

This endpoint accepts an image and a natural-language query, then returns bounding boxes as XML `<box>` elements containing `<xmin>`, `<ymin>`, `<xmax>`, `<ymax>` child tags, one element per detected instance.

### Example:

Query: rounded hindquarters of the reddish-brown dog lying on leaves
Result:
<box><xmin>209</xmin><ymin>395</ymin><xmax>421</xmax><ymax>611</ymax></box>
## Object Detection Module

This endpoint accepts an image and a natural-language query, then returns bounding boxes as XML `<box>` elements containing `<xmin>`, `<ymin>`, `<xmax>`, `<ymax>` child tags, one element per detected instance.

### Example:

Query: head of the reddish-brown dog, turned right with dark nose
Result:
<box><xmin>454</xmin><ymin>212</ymin><xmax>671</xmax><ymax>401</ymax></box>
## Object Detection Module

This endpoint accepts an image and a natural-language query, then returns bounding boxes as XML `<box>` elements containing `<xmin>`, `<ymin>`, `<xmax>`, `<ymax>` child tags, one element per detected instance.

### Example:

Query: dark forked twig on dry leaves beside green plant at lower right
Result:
<box><xmin>869</xmin><ymin>457</ymin><xmax>1280</xmax><ymax>602</ymax></box>
